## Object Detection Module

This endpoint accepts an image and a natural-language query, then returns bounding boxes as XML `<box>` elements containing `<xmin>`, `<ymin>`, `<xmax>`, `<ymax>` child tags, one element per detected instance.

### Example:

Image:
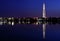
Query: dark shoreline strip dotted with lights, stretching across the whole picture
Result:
<box><xmin>0</xmin><ymin>17</ymin><xmax>60</xmax><ymax>25</ymax></box>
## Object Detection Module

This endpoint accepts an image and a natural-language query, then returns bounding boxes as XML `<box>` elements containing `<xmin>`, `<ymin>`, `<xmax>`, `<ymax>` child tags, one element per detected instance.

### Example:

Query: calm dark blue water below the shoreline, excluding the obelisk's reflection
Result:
<box><xmin>0</xmin><ymin>24</ymin><xmax>60</xmax><ymax>41</ymax></box>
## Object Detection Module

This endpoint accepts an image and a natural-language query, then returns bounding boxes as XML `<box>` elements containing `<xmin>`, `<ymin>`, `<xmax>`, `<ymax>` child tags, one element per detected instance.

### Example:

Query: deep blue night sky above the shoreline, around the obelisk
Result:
<box><xmin>0</xmin><ymin>0</ymin><xmax>60</xmax><ymax>17</ymax></box>
